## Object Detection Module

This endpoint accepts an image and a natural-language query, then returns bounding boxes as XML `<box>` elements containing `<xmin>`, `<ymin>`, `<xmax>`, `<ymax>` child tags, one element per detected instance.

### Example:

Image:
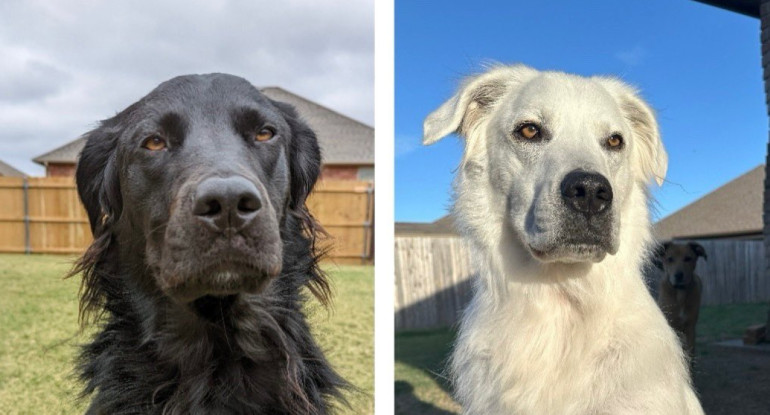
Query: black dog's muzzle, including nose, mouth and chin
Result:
<box><xmin>159</xmin><ymin>175</ymin><xmax>282</xmax><ymax>303</ymax></box>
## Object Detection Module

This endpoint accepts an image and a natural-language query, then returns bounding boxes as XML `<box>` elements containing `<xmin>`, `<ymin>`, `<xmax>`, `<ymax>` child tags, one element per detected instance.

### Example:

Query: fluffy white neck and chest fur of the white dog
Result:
<box><xmin>451</xmin><ymin>193</ymin><xmax>698</xmax><ymax>415</ymax></box>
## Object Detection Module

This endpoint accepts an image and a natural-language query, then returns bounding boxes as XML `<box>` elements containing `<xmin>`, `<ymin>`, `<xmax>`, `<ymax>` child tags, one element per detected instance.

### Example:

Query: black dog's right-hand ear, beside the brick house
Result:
<box><xmin>273</xmin><ymin>101</ymin><xmax>321</xmax><ymax>210</ymax></box>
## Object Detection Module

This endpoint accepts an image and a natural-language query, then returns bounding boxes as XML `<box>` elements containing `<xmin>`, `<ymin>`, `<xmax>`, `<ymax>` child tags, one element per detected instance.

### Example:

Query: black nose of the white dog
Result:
<box><xmin>561</xmin><ymin>170</ymin><xmax>612</xmax><ymax>217</ymax></box>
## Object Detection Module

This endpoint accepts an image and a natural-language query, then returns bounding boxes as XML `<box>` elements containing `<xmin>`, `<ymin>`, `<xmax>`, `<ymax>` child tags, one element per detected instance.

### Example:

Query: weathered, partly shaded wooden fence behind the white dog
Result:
<box><xmin>394</xmin><ymin>237</ymin><xmax>770</xmax><ymax>330</ymax></box>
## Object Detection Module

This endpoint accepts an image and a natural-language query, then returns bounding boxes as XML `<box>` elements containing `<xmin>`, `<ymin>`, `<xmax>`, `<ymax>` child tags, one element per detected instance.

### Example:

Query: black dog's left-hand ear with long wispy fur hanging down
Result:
<box><xmin>68</xmin><ymin>122</ymin><xmax>123</xmax><ymax>325</ymax></box>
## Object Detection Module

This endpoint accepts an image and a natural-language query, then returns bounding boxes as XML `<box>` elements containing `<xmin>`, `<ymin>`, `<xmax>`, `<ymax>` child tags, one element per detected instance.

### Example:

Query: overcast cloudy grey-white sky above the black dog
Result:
<box><xmin>0</xmin><ymin>0</ymin><xmax>374</xmax><ymax>175</ymax></box>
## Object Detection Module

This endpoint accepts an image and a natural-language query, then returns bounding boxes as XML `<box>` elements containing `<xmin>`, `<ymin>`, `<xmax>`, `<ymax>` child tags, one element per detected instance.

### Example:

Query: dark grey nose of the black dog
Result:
<box><xmin>193</xmin><ymin>176</ymin><xmax>262</xmax><ymax>231</ymax></box>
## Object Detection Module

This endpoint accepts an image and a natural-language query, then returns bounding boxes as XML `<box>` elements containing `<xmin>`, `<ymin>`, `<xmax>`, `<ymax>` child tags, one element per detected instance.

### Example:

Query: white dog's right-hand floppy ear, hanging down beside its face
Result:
<box><xmin>598</xmin><ymin>78</ymin><xmax>668</xmax><ymax>186</ymax></box>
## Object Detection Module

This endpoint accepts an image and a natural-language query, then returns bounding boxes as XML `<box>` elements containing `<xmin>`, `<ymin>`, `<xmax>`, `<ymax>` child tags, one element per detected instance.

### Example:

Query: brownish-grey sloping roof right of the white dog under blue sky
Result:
<box><xmin>654</xmin><ymin>165</ymin><xmax>765</xmax><ymax>240</ymax></box>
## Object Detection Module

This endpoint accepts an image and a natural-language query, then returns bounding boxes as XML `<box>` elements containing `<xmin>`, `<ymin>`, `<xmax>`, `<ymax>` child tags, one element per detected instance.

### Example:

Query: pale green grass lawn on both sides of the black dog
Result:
<box><xmin>0</xmin><ymin>255</ymin><xmax>374</xmax><ymax>415</ymax></box>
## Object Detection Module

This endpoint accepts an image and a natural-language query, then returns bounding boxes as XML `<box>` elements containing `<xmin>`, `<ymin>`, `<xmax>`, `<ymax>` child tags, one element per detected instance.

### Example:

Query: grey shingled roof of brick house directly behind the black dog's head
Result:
<box><xmin>33</xmin><ymin>87</ymin><xmax>374</xmax><ymax>165</ymax></box>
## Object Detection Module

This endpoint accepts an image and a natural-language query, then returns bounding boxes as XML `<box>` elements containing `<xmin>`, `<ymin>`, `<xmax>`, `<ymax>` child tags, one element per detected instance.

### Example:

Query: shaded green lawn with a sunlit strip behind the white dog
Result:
<box><xmin>395</xmin><ymin>303</ymin><xmax>768</xmax><ymax>415</ymax></box>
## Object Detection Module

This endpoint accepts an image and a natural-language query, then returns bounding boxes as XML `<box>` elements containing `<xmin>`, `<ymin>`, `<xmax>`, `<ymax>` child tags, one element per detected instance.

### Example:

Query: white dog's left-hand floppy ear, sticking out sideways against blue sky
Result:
<box><xmin>422</xmin><ymin>65</ymin><xmax>537</xmax><ymax>145</ymax></box>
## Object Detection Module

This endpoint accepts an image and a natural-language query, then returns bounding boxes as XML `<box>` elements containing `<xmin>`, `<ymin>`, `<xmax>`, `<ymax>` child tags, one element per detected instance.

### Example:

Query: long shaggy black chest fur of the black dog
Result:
<box><xmin>80</xmin><ymin>266</ymin><xmax>344</xmax><ymax>415</ymax></box>
